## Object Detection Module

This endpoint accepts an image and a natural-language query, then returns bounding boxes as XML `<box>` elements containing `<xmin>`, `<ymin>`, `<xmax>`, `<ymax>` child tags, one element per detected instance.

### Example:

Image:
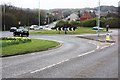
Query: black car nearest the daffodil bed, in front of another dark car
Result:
<box><xmin>13</xmin><ymin>29</ymin><xmax>29</xmax><ymax>37</ymax></box>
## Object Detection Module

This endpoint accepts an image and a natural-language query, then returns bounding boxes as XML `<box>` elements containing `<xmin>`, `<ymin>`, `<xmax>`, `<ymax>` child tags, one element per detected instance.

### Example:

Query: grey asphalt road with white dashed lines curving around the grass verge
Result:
<box><xmin>1</xmin><ymin>30</ymin><xmax>118</xmax><ymax>78</ymax></box>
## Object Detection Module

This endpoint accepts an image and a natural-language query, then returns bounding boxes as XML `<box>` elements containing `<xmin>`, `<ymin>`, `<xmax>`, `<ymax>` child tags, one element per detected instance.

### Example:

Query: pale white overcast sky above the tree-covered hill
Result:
<box><xmin>0</xmin><ymin>0</ymin><xmax>119</xmax><ymax>9</ymax></box>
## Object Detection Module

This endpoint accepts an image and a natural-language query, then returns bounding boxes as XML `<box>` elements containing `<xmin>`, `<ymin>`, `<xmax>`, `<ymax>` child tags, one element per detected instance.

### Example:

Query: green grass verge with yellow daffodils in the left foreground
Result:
<box><xmin>1</xmin><ymin>39</ymin><xmax>59</xmax><ymax>56</ymax></box>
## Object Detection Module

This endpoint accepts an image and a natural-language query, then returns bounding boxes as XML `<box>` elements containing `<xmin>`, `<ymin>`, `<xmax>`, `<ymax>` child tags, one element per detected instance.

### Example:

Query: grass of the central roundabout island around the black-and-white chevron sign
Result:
<box><xmin>30</xmin><ymin>27</ymin><xmax>105</xmax><ymax>34</ymax></box>
